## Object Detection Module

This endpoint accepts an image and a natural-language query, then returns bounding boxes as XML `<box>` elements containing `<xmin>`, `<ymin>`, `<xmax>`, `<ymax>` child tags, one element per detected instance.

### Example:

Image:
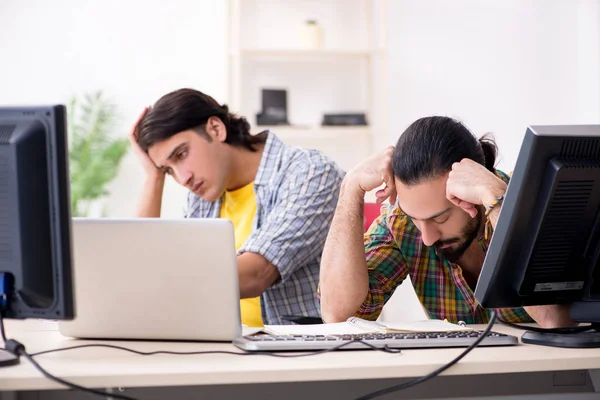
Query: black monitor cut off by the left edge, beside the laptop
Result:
<box><xmin>0</xmin><ymin>105</ymin><xmax>74</xmax><ymax>363</ymax></box>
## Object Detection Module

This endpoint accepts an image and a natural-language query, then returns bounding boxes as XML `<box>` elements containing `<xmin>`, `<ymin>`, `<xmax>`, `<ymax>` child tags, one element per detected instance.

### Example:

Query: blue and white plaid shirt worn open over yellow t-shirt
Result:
<box><xmin>185</xmin><ymin>132</ymin><xmax>344</xmax><ymax>324</ymax></box>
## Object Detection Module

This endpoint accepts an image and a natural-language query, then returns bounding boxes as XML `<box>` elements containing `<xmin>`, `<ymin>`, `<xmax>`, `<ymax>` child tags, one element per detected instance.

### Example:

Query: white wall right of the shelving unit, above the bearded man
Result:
<box><xmin>387</xmin><ymin>0</ymin><xmax>600</xmax><ymax>170</ymax></box>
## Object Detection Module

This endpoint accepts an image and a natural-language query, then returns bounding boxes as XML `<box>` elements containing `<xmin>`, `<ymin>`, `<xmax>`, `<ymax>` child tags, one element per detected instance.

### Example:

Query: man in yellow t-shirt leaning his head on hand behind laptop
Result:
<box><xmin>130</xmin><ymin>89</ymin><xmax>343</xmax><ymax>326</ymax></box>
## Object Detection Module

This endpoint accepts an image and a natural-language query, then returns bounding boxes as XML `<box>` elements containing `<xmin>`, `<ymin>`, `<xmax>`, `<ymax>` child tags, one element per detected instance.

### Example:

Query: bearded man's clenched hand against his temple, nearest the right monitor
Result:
<box><xmin>446</xmin><ymin>158</ymin><xmax>507</xmax><ymax>218</ymax></box>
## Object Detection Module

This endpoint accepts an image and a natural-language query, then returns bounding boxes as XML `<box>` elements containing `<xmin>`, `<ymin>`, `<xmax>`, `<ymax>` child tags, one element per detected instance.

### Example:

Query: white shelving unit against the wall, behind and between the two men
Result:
<box><xmin>229</xmin><ymin>0</ymin><xmax>386</xmax><ymax>170</ymax></box>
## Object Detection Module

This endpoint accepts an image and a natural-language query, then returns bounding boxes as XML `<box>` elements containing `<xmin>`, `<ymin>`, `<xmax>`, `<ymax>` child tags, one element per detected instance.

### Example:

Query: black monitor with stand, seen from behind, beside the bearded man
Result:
<box><xmin>475</xmin><ymin>125</ymin><xmax>600</xmax><ymax>347</ymax></box>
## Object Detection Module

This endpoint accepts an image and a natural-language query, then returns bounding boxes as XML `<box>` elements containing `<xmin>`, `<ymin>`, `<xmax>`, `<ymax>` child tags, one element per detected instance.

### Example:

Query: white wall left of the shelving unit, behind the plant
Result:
<box><xmin>0</xmin><ymin>0</ymin><xmax>227</xmax><ymax>217</ymax></box>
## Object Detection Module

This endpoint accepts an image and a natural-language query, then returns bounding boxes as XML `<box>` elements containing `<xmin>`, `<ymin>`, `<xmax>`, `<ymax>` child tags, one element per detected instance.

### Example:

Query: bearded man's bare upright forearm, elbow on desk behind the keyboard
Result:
<box><xmin>320</xmin><ymin>180</ymin><xmax>369</xmax><ymax>322</ymax></box>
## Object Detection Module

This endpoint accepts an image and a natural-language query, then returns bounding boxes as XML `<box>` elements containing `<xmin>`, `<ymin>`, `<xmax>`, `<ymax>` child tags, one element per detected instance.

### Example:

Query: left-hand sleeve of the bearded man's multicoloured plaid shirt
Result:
<box><xmin>355</xmin><ymin>208</ymin><xmax>408</xmax><ymax>320</ymax></box>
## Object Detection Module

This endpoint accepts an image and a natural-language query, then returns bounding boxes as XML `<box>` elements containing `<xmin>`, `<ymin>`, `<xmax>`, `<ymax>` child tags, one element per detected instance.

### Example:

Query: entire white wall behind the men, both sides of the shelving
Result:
<box><xmin>0</xmin><ymin>0</ymin><xmax>600</xmax><ymax>216</ymax></box>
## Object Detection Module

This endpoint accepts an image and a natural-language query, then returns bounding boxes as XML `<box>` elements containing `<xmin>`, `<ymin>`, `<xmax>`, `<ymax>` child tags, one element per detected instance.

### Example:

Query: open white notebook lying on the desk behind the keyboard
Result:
<box><xmin>263</xmin><ymin>317</ymin><xmax>472</xmax><ymax>336</ymax></box>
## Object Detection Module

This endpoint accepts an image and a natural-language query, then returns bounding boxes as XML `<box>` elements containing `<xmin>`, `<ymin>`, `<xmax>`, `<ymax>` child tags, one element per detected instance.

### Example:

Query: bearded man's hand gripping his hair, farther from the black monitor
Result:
<box><xmin>345</xmin><ymin>146</ymin><xmax>396</xmax><ymax>204</ymax></box>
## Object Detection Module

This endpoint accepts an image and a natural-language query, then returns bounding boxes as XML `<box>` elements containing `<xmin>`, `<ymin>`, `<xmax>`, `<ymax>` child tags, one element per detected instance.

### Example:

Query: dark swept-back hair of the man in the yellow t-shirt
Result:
<box><xmin>137</xmin><ymin>89</ymin><xmax>265</xmax><ymax>151</ymax></box>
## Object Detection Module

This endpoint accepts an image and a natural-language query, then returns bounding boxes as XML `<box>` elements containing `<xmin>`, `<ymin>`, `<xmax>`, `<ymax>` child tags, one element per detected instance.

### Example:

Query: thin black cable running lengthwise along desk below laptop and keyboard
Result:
<box><xmin>30</xmin><ymin>339</ymin><xmax>401</xmax><ymax>358</ymax></box>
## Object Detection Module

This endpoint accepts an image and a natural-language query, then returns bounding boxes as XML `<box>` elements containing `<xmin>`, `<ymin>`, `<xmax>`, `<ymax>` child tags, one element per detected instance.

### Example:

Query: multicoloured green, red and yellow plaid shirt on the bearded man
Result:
<box><xmin>356</xmin><ymin>173</ymin><xmax>533</xmax><ymax>324</ymax></box>
